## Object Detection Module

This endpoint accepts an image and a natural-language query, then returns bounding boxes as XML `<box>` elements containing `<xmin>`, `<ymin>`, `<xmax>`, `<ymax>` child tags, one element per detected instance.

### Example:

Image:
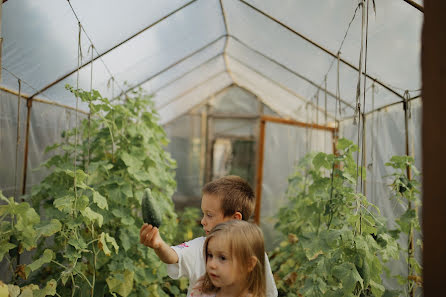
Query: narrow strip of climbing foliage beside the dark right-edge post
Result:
<box><xmin>385</xmin><ymin>156</ymin><xmax>422</xmax><ymax>294</ymax></box>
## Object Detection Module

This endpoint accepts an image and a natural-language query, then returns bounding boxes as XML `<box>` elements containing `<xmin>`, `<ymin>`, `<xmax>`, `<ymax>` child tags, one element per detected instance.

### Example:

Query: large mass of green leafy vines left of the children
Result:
<box><xmin>2</xmin><ymin>87</ymin><xmax>179</xmax><ymax>296</ymax></box>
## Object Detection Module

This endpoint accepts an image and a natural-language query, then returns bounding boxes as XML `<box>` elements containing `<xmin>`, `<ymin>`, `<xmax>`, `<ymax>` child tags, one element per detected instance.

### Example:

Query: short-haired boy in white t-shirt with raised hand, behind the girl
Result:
<box><xmin>140</xmin><ymin>176</ymin><xmax>277</xmax><ymax>297</ymax></box>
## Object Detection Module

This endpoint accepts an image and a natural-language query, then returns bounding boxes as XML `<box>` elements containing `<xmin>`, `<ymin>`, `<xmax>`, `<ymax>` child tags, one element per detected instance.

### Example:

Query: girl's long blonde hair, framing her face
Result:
<box><xmin>201</xmin><ymin>220</ymin><xmax>266</xmax><ymax>297</ymax></box>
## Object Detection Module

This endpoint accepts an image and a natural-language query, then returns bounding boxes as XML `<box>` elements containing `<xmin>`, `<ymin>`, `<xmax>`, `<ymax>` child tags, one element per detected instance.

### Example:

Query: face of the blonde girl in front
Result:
<box><xmin>206</xmin><ymin>236</ymin><xmax>245</xmax><ymax>288</ymax></box>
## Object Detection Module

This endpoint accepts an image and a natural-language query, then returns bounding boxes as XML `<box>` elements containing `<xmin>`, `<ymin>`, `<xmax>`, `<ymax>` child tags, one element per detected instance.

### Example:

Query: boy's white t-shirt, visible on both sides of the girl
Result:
<box><xmin>167</xmin><ymin>237</ymin><xmax>277</xmax><ymax>297</ymax></box>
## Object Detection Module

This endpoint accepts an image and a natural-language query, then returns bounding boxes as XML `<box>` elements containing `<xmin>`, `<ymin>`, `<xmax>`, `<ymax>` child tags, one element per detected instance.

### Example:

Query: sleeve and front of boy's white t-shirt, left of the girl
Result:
<box><xmin>167</xmin><ymin>237</ymin><xmax>206</xmax><ymax>293</ymax></box>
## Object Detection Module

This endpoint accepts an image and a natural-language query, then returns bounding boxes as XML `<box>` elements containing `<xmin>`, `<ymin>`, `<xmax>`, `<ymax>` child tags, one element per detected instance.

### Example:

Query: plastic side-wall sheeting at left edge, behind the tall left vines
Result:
<box><xmin>0</xmin><ymin>91</ymin><xmax>86</xmax><ymax>197</ymax></box>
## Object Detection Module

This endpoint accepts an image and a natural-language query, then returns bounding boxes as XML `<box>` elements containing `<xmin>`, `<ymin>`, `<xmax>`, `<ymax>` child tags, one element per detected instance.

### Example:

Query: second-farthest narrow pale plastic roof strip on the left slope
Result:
<box><xmin>154</xmin><ymin>56</ymin><xmax>226</xmax><ymax>107</ymax></box>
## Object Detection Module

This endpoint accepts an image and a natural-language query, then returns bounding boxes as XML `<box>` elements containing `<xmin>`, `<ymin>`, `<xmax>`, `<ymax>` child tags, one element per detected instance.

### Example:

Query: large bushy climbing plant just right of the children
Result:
<box><xmin>270</xmin><ymin>139</ymin><xmax>399</xmax><ymax>297</ymax></box>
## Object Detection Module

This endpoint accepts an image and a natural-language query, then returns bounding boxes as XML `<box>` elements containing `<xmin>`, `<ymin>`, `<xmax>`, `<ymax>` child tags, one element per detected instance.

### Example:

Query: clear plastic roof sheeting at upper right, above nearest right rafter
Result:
<box><xmin>244</xmin><ymin>0</ymin><xmax>423</xmax><ymax>94</ymax></box>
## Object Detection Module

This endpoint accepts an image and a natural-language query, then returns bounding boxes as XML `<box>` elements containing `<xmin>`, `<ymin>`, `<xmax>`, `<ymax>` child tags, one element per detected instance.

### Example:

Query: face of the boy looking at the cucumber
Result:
<box><xmin>201</xmin><ymin>194</ymin><xmax>232</xmax><ymax>235</ymax></box>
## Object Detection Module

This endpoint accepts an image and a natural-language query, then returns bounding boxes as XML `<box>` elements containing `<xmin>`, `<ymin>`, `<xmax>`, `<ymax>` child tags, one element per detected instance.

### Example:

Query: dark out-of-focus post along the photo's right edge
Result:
<box><xmin>421</xmin><ymin>0</ymin><xmax>446</xmax><ymax>297</ymax></box>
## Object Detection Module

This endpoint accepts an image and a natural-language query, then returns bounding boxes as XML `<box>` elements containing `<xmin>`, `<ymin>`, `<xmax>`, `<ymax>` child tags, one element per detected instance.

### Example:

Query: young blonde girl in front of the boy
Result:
<box><xmin>190</xmin><ymin>220</ymin><xmax>265</xmax><ymax>297</ymax></box>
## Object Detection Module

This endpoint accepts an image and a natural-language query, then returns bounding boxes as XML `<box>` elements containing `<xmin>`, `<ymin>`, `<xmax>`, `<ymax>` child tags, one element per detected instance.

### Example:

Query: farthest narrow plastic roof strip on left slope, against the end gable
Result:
<box><xmin>159</xmin><ymin>73</ymin><xmax>232</xmax><ymax>124</ymax></box>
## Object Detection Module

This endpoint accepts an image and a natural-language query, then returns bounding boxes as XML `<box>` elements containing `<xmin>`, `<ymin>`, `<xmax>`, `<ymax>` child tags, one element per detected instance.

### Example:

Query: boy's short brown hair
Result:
<box><xmin>202</xmin><ymin>175</ymin><xmax>255</xmax><ymax>221</ymax></box>
